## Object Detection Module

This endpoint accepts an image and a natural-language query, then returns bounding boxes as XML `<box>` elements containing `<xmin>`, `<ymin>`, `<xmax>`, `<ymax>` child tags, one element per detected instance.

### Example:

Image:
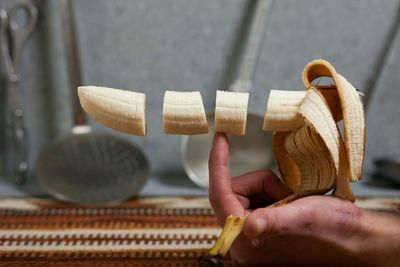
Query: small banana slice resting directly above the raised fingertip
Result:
<box><xmin>215</xmin><ymin>91</ymin><xmax>249</xmax><ymax>135</ymax></box>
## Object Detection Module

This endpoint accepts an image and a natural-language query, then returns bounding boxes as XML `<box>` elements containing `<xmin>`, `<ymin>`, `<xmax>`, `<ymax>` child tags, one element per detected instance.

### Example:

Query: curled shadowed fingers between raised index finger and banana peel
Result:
<box><xmin>232</xmin><ymin>170</ymin><xmax>293</xmax><ymax>204</ymax></box>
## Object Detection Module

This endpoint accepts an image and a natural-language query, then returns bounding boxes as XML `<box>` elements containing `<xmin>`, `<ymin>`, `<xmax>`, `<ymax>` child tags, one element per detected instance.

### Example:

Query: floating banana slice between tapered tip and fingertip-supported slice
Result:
<box><xmin>163</xmin><ymin>91</ymin><xmax>208</xmax><ymax>135</ymax></box>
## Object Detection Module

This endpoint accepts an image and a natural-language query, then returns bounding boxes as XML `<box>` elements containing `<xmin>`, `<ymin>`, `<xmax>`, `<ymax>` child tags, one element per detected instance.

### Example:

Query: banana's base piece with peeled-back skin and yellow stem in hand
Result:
<box><xmin>210</xmin><ymin>59</ymin><xmax>365</xmax><ymax>262</ymax></box>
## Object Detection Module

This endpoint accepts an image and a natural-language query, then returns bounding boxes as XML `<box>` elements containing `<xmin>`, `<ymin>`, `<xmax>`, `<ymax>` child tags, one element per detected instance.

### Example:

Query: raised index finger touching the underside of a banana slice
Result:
<box><xmin>208</xmin><ymin>133</ymin><xmax>244</xmax><ymax>225</ymax></box>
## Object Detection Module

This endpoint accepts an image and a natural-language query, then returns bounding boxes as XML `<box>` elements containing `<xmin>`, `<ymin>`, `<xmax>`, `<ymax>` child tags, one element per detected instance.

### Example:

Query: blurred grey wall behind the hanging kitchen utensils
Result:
<box><xmin>0</xmin><ymin>0</ymin><xmax>400</xmax><ymax>201</ymax></box>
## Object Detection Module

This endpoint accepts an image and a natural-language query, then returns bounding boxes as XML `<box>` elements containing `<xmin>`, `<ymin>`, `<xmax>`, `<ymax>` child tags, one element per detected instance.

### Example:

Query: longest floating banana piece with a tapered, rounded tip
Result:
<box><xmin>78</xmin><ymin>86</ymin><xmax>146</xmax><ymax>136</ymax></box>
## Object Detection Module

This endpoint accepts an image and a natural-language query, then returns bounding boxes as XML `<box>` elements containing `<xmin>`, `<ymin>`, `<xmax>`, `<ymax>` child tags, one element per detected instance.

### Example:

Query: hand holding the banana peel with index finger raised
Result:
<box><xmin>209</xmin><ymin>134</ymin><xmax>400</xmax><ymax>266</ymax></box>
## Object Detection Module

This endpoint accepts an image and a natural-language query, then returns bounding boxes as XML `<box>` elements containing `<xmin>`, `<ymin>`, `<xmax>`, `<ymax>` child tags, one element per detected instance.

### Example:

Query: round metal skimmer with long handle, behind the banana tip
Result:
<box><xmin>37</xmin><ymin>0</ymin><xmax>149</xmax><ymax>205</ymax></box>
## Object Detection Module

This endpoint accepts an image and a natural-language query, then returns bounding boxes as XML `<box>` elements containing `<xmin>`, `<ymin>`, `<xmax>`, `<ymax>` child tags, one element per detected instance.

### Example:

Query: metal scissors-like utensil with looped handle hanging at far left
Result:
<box><xmin>0</xmin><ymin>1</ymin><xmax>38</xmax><ymax>184</ymax></box>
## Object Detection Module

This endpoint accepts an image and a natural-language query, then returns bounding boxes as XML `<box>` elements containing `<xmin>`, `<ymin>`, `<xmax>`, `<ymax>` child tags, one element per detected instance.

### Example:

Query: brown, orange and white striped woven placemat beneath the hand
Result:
<box><xmin>0</xmin><ymin>197</ymin><xmax>400</xmax><ymax>266</ymax></box>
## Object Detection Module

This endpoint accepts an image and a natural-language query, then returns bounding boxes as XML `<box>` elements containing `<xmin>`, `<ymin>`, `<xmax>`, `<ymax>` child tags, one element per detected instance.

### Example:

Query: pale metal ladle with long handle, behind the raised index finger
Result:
<box><xmin>181</xmin><ymin>0</ymin><xmax>273</xmax><ymax>187</ymax></box>
